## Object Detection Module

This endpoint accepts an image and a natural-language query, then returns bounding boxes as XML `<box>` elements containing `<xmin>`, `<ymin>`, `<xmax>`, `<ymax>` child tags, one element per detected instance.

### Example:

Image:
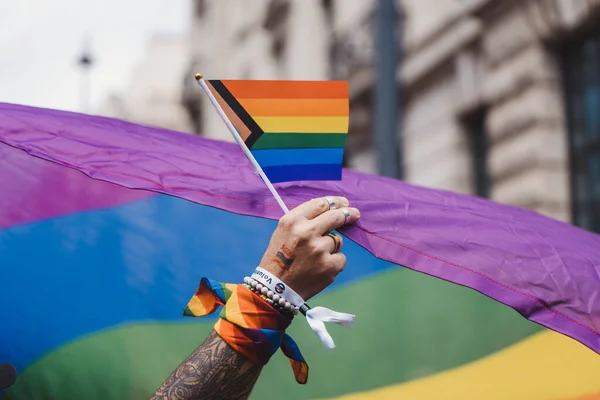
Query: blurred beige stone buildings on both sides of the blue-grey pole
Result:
<box><xmin>183</xmin><ymin>0</ymin><xmax>600</xmax><ymax>231</ymax></box>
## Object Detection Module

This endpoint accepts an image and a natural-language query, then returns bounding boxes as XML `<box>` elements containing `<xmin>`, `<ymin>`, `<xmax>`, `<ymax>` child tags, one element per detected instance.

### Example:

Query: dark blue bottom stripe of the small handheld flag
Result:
<box><xmin>263</xmin><ymin>164</ymin><xmax>342</xmax><ymax>183</ymax></box>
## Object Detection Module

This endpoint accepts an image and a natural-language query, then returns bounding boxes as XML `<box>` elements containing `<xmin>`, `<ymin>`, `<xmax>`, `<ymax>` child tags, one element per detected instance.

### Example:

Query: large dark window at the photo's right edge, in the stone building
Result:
<box><xmin>563</xmin><ymin>33</ymin><xmax>600</xmax><ymax>232</ymax></box>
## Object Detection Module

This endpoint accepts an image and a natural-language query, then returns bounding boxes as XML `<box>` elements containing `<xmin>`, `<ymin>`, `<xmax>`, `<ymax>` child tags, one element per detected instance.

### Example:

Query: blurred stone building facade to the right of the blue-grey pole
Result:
<box><xmin>390</xmin><ymin>0</ymin><xmax>600</xmax><ymax>231</ymax></box>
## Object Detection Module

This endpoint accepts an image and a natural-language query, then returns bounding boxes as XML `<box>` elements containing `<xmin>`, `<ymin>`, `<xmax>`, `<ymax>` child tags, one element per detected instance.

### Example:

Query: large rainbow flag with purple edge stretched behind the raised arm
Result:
<box><xmin>0</xmin><ymin>104</ymin><xmax>600</xmax><ymax>400</ymax></box>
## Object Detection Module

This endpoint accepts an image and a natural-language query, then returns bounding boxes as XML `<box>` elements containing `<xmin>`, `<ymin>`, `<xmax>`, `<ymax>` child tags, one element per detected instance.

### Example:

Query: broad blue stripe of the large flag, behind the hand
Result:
<box><xmin>0</xmin><ymin>195</ymin><xmax>393</xmax><ymax>371</ymax></box>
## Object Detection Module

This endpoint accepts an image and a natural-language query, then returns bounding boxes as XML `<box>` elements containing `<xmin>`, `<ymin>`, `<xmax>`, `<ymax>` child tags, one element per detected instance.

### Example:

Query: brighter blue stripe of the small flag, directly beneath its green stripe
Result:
<box><xmin>252</xmin><ymin>148</ymin><xmax>344</xmax><ymax>168</ymax></box>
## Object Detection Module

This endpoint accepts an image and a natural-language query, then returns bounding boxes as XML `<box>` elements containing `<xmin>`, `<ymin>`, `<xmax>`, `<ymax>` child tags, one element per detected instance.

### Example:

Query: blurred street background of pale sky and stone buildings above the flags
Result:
<box><xmin>0</xmin><ymin>0</ymin><xmax>600</xmax><ymax>232</ymax></box>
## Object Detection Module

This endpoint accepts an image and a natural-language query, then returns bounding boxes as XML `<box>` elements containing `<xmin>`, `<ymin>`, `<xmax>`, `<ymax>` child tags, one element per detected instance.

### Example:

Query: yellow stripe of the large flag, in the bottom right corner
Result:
<box><xmin>326</xmin><ymin>331</ymin><xmax>600</xmax><ymax>400</ymax></box>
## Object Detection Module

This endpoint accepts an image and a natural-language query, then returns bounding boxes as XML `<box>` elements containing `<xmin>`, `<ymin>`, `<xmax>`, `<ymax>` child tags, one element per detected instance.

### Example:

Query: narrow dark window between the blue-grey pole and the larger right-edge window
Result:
<box><xmin>463</xmin><ymin>108</ymin><xmax>491</xmax><ymax>198</ymax></box>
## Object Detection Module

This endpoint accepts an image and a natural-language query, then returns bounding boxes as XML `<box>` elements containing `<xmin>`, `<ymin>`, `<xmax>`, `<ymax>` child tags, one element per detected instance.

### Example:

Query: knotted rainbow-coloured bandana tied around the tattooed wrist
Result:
<box><xmin>183</xmin><ymin>278</ymin><xmax>308</xmax><ymax>384</ymax></box>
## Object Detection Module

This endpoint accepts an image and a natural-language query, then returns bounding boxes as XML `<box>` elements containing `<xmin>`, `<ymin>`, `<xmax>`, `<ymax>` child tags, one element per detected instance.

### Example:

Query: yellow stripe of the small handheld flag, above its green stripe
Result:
<box><xmin>254</xmin><ymin>117</ymin><xmax>348</xmax><ymax>133</ymax></box>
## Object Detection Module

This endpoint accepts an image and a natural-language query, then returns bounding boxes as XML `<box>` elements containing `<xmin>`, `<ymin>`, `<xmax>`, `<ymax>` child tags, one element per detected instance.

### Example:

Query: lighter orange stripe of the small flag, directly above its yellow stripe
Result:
<box><xmin>239</xmin><ymin>99</ymin><xmax>348</xmax><ymax>117</ymax></box>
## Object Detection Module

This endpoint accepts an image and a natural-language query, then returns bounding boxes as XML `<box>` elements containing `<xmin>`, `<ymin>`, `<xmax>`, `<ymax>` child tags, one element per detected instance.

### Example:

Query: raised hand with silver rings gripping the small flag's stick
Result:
<box><xmin>259</xmin><ymin>196</ymin><xmax>360</xmax><ymax>300</ymax></box>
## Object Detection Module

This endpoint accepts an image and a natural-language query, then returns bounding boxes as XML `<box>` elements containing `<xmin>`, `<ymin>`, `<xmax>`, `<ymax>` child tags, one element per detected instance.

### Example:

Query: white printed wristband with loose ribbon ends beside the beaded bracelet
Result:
<box><xmin>252</xmin><ymin>267</ymin><xmax>354</xmax><ymax>349</ymax></box>
